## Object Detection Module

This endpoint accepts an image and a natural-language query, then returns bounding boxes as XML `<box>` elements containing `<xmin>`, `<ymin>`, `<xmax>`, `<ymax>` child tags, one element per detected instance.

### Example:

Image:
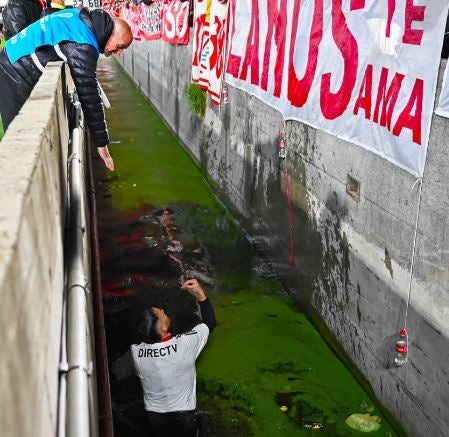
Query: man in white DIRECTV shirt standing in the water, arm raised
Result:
<box><xmin>112</xmin><ymin>279</ymin><xmax>216</xmax><ymax>437</ymax></box>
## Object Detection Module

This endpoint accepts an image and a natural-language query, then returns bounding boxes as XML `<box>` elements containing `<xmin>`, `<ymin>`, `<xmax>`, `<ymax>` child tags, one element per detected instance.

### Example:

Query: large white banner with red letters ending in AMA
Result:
<box><xmin>226</xmin><ymin>0</ymin><xmax>448</xmax><ymax>176</ymax></box>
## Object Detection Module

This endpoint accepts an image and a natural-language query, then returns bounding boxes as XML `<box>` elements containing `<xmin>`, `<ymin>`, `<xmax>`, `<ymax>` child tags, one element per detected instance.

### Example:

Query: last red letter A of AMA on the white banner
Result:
<box><xmin>393</xmin><ymin>79</ymin><xmax>424</xmax><ymax>145</ymax></box>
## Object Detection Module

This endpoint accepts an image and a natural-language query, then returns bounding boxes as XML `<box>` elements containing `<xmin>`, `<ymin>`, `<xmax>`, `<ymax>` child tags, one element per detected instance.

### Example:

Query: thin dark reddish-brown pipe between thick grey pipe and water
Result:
<box><xmin>86</xmin><ymin>130</ymin><xmax>114</xmax><ymax>437</ymax></box>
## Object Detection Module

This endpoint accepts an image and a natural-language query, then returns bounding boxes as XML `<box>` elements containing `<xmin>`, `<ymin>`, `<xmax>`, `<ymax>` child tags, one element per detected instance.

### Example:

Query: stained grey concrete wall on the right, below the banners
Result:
<box><xmin>119</xmin><ymin>35</ymin><xmax>449</xmax><ymax>437</ymax></box>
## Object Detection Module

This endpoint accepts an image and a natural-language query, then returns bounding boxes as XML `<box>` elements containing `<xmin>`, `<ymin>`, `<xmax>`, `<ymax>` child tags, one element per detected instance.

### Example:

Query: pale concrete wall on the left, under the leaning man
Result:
<box><xmin>0</xmin><ymin>64</ymin><xmax>97</xmax><ymax>437</ymax></box>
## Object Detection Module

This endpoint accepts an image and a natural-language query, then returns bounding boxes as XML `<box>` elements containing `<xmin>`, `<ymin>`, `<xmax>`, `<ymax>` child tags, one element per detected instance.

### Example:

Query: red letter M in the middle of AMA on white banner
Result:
<box><xmin>373</xmin><ymin>67</ymin><xmax>404</xmax><ymax>130</ymax></box>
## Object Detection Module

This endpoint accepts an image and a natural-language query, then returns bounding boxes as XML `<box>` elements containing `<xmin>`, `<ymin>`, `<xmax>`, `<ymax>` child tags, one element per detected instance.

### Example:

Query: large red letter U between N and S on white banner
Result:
<box><xmin>287</xmin><ymin>0</ymin><xmax>323</xmax><ymax>108</ymax></box>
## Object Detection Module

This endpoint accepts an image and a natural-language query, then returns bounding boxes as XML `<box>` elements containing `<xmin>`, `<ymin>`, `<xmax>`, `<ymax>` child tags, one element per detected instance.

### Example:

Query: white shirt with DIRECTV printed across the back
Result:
<box><xmin>131</xmin><ymin>323</ymin><xmax>209</xmax><ymax>413</ymax></box>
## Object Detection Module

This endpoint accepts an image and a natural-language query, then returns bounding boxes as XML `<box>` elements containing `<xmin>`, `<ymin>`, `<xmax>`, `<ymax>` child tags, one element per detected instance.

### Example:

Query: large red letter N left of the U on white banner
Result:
<box><xmin>260</xmin><ymin>0</ymin><xmax>287</xmax><ymax>97</ymax></box>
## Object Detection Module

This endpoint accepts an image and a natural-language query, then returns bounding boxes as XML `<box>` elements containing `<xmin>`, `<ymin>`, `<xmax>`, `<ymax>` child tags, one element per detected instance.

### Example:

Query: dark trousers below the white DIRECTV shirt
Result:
<box><xmin>146</xmin><ymin>410</ymin><xmax>199</xmax><ymax>437</ymax></box>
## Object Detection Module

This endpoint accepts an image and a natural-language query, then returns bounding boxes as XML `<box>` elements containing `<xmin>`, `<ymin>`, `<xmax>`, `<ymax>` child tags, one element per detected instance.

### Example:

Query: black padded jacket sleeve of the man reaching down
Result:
<box><xmin>60</xmin><ymin>42</ymin><xmax>109</xmax><ymax>147</ymax></box>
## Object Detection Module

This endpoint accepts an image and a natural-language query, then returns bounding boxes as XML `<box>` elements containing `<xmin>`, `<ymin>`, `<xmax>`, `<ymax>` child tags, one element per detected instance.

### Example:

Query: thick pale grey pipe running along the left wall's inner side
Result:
<box><xmin>67</xmin><ymin>102</ymin><xmax>92</xmax><ymax>437</ymax></box>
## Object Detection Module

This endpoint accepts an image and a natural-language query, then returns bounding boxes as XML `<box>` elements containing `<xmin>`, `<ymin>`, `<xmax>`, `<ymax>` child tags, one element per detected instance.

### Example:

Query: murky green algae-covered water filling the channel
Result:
<box><xmin>96</xmin><ymin>60</ymin><xmax>403</xmax><ymax>437</ymax></box>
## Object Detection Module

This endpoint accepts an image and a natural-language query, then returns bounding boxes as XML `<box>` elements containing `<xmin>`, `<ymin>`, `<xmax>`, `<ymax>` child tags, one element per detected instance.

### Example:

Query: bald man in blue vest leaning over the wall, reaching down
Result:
<box><xmin>0</xmin><ymin>9</ymin><xmax>133</xmax><ymax>171</ymax></box>
